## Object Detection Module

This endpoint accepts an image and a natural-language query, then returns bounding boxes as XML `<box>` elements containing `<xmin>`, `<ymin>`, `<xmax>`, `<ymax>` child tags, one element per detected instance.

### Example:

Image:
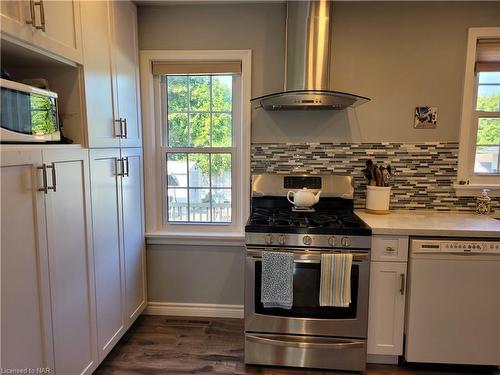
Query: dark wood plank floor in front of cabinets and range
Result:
<box><xmin>95</xmin><ymin>316</ymin><xmax>500</xmax><ymax>375</ymax></box>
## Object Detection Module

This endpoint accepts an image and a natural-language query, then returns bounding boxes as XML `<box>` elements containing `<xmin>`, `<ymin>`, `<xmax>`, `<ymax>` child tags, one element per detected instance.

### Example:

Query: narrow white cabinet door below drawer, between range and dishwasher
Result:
<box><xmin>367</xmin><ymin>262</ymin><xmax>406</xmax><ymax>355</ymax></box>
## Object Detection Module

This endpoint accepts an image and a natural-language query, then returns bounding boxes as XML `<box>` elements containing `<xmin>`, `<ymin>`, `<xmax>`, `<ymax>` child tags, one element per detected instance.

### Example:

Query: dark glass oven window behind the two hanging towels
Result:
<box><xmin>255</xmin><ymin>261</ymin><xmax>359</xmax><ymax>319</ymax></box>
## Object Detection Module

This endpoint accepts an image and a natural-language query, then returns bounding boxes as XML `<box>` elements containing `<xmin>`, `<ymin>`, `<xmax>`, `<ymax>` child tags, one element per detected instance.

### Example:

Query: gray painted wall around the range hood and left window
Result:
<box><xmin>138</xmin><ymin>2</ymin><xmax>500</xmax><ymax>304</ymax></box>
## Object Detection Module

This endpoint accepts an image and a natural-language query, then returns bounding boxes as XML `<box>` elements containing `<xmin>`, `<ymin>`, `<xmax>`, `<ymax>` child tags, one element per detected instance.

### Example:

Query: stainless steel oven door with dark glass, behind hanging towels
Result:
<box><xmin>245</xmin><ymin>248</ymin><xmax>370</xmax><ymax>338</ymax></box>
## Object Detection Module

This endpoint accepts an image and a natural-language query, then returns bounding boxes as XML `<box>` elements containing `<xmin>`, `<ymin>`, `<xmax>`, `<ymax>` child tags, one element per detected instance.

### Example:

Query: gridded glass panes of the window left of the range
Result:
<box><xmin>162</xmin><ymin>74</ymin><xmax>234</xmax><ymax>223</ymax></box>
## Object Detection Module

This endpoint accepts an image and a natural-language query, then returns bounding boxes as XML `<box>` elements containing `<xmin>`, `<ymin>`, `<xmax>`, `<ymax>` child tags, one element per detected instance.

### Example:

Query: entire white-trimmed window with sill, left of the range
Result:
<box><xmin>141</xmin><ymin>50</ymin><xmax>251</xmax><ymax>241</ymax></box>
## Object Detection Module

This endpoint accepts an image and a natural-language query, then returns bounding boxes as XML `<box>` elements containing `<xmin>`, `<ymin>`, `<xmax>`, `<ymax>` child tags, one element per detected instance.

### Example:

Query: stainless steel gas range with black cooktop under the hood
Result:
<box><xmin>245</xmin><ymin>174</ymin><xmax>371</xmax><ymax>371</ymax></box>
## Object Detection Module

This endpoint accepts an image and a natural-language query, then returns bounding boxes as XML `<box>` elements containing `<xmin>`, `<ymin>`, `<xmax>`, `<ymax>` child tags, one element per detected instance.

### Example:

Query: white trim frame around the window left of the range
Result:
<box><xmin>140</xmin><ymin>50</ymin><xmax>252</xmax><ymax>246</ymax></box>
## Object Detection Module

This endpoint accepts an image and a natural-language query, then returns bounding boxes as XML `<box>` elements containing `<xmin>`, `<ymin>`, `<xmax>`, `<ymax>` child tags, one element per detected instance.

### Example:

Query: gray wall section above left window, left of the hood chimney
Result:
<box><xmin>138</xmin><ymin>3</ymin><xmax>285</xmax><ymax>96</ymax></box>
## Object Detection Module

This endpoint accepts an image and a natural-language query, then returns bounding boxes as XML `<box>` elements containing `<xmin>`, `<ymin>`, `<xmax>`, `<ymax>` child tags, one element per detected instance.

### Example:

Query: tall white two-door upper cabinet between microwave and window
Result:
<box><xmin>81</xmin><ymin>1</ymin><xmax>142</xmax><ymax>147</ymax></box>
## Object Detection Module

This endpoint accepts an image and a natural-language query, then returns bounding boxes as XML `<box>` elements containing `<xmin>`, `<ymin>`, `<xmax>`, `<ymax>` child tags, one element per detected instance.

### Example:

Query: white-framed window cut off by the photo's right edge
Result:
<box><xmin>456</xmin><ymin>27</ymin><xmax>500</xmax><ymax>195</ymax></box>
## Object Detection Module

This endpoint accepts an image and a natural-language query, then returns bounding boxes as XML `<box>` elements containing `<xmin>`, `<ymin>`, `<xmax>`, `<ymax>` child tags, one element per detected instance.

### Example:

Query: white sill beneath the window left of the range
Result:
<box><xmin>146</xmin><ymin>232</ymin><xmax>245</xmax><ymax>246</ymax></box>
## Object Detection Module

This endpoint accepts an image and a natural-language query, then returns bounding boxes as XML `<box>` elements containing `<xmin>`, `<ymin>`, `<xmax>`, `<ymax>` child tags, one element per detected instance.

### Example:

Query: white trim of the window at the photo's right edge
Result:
<box><xmin>454</xmin><ymin>27</ymin><xmax>500</xmax><ymax>196</ymax></box>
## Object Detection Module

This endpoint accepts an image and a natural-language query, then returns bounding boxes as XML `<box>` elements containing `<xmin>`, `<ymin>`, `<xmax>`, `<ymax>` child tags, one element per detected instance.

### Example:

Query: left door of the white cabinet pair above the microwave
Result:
<box><xmin>0</xmin><ymin>0</ymin><xmax>35</xmax><ymax>43</ymax></box>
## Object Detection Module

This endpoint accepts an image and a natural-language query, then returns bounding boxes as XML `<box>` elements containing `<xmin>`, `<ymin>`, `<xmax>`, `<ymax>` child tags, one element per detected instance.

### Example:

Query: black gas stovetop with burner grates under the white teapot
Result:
<box><xmin>245</xmin><ymin>206</ymin><xmax>371</xmax><ymax>235</ymax></box>
